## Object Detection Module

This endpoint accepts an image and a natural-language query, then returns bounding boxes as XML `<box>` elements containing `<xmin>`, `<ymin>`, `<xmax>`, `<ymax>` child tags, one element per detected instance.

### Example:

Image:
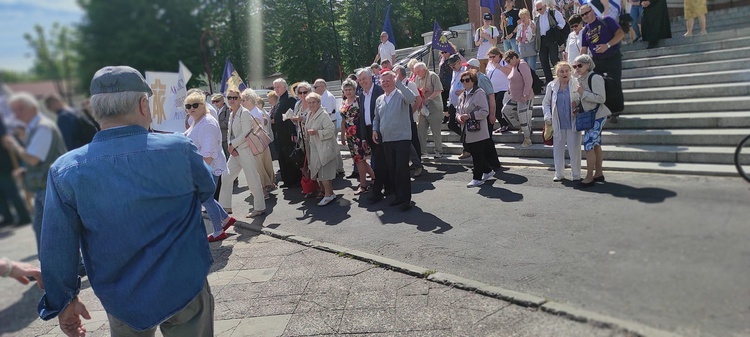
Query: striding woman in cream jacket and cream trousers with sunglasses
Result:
<box><xmin>219</xmin><ymin>89</ymin><xmax>266</xmax><ymax>218</ymax></box>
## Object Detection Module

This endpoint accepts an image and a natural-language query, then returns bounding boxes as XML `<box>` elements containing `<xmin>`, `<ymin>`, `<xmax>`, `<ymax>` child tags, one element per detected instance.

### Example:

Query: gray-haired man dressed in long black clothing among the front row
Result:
<box><xmin>272</xmin><ymin>78</ymin><xmax>302</xmax><ymax>187</ymax></box>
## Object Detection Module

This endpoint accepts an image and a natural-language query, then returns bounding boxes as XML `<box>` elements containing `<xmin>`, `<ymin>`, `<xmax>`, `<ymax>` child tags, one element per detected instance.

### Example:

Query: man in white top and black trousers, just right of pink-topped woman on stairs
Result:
<box><xmin>534</xmin><ymin>0</ymin><xmax>565</xmax><ymax>83</ymax></box>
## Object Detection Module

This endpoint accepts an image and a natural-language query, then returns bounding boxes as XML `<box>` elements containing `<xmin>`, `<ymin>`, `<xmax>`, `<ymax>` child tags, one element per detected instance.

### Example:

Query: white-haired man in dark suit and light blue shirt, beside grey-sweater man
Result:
<box><xmin>357</xmin><ymin>68</ymin><xmax>391</xmax><ymax>202</ymax></box>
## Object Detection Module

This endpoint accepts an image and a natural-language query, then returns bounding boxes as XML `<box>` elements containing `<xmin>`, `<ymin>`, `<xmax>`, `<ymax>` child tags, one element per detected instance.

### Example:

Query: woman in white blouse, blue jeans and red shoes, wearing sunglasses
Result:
<box><xmin>184</xmin><ymin>93</ymin><xmax>235</xmax><ymax>242</ymax></box>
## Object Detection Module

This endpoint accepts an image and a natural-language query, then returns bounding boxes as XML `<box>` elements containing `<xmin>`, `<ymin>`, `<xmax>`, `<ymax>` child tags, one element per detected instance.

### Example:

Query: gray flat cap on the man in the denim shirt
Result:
<box><xmin>91</xmin><ymin>66</ymin><xmax>153</xmax><ymax>96</ymax></box>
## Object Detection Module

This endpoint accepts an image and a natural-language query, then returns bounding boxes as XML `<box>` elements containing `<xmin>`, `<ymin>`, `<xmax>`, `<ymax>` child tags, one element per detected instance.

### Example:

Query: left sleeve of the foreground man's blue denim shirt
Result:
<box><xmin>37</xmin><ymin>169</ymin><xmax>83</xmax><ymax>320</ymax></box>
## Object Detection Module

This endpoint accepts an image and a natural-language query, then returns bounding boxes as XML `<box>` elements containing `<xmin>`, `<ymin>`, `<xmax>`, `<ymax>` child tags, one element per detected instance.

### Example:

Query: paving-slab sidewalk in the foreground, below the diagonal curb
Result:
<box><xmin>0</xmin><ymin>226</ymin><xmax>629</xmax><ymax>337</ymax></box>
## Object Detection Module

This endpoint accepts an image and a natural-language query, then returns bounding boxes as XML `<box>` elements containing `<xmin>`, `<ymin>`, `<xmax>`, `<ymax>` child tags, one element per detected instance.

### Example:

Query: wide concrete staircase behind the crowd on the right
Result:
<box><xmin>418</xmin><ymin>7</ymin><xmax>750</xmax><ymax>175</ymax></box>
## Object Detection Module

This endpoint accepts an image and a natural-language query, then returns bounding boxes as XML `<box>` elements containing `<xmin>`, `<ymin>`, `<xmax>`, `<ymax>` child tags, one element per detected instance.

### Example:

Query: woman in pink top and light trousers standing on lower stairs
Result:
<box><xmin>503</xmin><ymin>50</ymin><xmax>534</xmax><ymax>147</ymax></box>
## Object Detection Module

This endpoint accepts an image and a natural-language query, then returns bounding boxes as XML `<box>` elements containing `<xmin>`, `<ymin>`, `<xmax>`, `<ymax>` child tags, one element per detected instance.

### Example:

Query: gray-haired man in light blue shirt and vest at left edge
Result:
<box><xmin>3</xmin><ymin>92</ymin><xmax>67</xmax><ymax>249</ymax></box>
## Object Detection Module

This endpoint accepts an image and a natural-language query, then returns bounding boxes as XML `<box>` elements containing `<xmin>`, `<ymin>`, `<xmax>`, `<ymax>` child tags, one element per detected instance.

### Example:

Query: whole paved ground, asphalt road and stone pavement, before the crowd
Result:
<box><xmin>0</xmin><ymin>161</ymin><xmax>750</xmax><ymax>336</ymax></box>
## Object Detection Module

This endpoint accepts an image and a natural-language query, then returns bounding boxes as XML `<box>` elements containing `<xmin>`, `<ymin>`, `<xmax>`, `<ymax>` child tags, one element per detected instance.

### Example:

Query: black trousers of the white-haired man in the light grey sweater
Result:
<box><xmin>383</xmin><ymin>140</ymin><xmax>412</xmax><ymax>203</ymax></box>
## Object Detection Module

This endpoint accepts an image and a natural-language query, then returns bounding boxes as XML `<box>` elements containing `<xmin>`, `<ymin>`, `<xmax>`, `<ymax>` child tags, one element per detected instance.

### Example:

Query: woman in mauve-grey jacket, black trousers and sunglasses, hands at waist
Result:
<box><xmin>456</xmin><ymin>70</ymin><xmax>495</xmax><ymax>187</ymax></box>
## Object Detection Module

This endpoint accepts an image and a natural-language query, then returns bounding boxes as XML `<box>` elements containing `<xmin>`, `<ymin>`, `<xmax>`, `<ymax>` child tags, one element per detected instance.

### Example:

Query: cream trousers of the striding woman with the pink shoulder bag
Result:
<box><xmin>219</xmin><ymin>147</ymin><xmax>266</xmax><ymax>211</ymax></box>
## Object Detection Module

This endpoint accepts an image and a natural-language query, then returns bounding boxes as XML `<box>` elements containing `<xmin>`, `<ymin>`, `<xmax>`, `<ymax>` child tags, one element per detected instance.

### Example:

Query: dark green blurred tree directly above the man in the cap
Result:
<box><xmin>78</xmin><ymin>0</ymin><xmax>205</xmax><ymax>90</ymax></box>
